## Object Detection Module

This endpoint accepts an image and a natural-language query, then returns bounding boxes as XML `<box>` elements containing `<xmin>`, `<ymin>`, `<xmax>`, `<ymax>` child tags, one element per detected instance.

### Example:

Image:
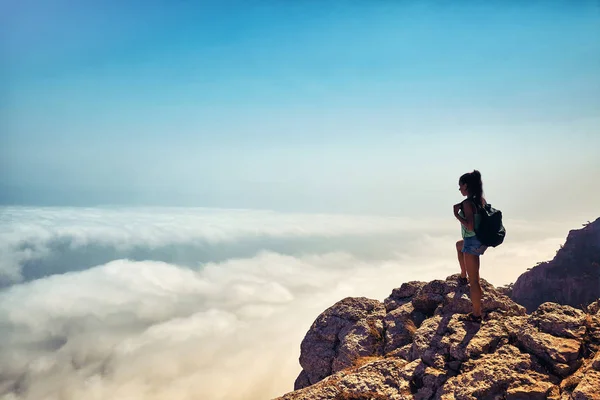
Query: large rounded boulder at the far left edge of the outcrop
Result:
<box><xmin>294</xmin><ymin>297</ymin><xmax>385</xmax><ymax>389</ymax></box>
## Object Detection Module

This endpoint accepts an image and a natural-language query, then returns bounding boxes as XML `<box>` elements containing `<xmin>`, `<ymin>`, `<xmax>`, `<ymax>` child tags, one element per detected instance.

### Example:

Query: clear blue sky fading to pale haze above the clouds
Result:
<box><xmin>0</xmin><ymin>1</ymin><xmax>600</xmax><ymax>219</ymax></box>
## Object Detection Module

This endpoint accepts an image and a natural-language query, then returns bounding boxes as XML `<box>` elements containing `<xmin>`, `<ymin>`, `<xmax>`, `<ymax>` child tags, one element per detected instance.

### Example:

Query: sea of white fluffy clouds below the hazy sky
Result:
<box><xmin>0</xmin><ymin>207</ymin><xmax>585</xmax><ymax>400</ymax></box>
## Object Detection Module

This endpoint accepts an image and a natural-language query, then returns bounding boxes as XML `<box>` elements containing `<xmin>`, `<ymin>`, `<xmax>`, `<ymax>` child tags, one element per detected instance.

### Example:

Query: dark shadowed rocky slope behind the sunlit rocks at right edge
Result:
<box><xmin>511</xmin><ymin>218</ymin><xmax>600</xmax><ymax>311</ymax></box>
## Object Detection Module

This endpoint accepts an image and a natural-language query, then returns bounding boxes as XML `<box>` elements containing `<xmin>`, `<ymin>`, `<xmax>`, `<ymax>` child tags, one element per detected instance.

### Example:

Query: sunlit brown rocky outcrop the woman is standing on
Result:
<box><xmin>279</xmin><ymin>275</ymin><xmax>600</xmax><ymax>400</ymax></box>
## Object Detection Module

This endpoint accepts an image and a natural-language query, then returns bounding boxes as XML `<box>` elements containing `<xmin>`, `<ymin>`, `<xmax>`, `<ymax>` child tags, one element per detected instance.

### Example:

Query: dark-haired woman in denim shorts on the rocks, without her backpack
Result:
<box><xmin>454</xmin><ymin>170</ymin><xmax>487</xmax><ymax>322</ymax></box>
